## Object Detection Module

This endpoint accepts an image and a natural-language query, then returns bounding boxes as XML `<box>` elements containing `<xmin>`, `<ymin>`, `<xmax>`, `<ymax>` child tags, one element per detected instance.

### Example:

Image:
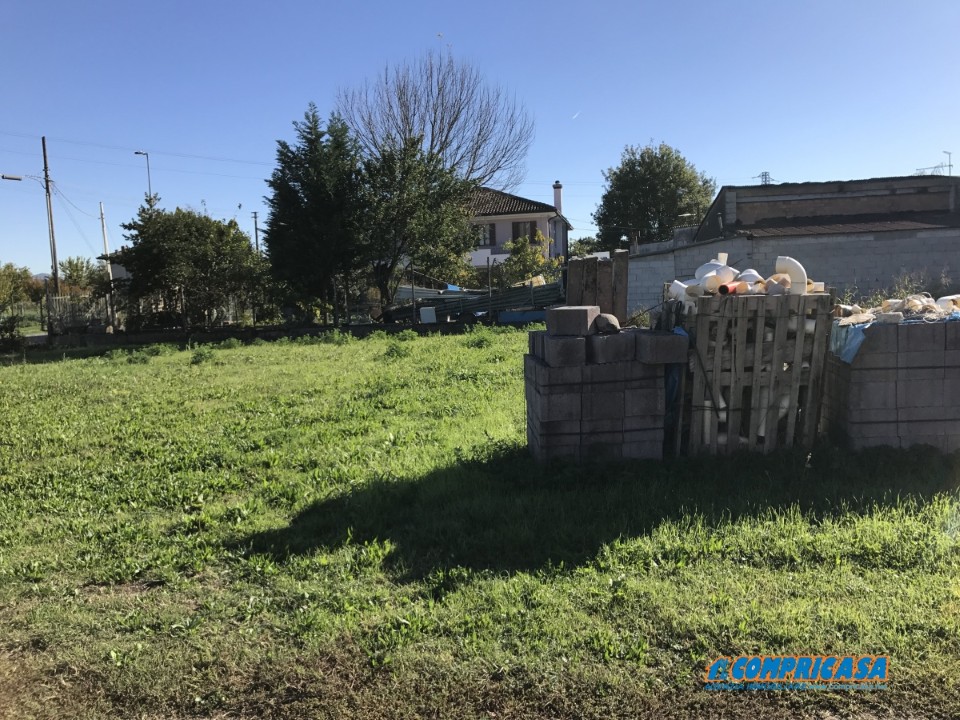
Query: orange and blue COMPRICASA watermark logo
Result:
<box><xmin>703</xmin><ymin>655</ymin><xmax>890</xmax><ymax>691</ymax></box>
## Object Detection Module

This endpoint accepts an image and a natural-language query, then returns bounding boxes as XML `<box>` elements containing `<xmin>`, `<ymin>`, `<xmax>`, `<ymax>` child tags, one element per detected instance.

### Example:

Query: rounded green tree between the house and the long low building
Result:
<box><xmin>593</xmin><ymin>143</ymin><xmax>716</xmax><ymax>250</ymax></box>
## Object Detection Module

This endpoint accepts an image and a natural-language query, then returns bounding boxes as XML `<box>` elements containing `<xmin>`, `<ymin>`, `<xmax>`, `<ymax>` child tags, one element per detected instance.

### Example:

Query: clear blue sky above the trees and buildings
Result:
<box><xmin>0</xmin><ymin>0</ymin><xmax>960</xmax><ymax>272</ymax></box>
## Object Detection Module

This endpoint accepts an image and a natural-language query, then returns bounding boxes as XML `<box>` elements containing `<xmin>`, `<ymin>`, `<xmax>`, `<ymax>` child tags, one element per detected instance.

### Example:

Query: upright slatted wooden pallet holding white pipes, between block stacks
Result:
<box><xmin>689</xmin><ymin>293</ymin><xmax>833</xmax><ymax>455</ymax></box>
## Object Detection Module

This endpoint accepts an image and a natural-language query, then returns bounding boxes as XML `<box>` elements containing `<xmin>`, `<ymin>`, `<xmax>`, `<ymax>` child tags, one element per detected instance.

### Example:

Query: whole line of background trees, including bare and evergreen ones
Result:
<box><xmin>0</xmin><ymin>53</ymin><xmax>715</xmax><ymax>338</ymax></box>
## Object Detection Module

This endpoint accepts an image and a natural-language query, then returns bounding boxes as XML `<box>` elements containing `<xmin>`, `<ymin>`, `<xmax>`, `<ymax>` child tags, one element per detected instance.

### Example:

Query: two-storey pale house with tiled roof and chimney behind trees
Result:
<box><xmin>470</xmin><ymin>180</ymin><xmax>573</xmax><ymax>268</ymax></box>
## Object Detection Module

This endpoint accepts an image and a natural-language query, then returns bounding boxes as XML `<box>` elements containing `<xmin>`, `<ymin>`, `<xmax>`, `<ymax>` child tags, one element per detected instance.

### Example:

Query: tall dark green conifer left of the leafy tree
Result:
<box><xmin>264</xmin><ymin>103</ymin><xmax>361</xmax><ymax>316</ymax></box>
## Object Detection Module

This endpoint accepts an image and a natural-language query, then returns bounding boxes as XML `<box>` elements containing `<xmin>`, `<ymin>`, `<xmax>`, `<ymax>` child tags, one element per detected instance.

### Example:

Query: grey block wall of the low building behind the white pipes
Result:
<box><xmin>629</xmin><ymin>229</ymin><xmax>960</xmax><ymax>312</ymax></box>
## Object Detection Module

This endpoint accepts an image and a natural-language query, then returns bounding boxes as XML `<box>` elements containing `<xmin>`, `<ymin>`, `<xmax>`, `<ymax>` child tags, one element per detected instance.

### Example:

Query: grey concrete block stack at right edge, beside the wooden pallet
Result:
<box><xmin>822</xmin><ymin>322</ymin><xmax>960</xmax><ymax>452</ymax></box>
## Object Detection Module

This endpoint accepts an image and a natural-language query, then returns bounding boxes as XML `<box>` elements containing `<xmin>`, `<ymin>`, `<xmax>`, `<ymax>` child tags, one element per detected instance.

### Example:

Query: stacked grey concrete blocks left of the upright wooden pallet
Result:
<box><xmin>524</xmin><ymin>306</ymin><xmax>686</xmax><ymax>461</ymax></box>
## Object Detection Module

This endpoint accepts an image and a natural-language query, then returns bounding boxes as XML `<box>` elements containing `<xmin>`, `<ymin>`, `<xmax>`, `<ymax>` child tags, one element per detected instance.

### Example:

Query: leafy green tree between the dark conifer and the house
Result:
<box><xmin>358</xmin><ymin>138</ymin><xmax>475</xmax><ymax>306</ymax></box>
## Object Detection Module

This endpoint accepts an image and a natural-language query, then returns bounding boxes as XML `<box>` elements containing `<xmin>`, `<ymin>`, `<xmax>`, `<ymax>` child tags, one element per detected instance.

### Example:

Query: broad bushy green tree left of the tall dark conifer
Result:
<box><xmin>117</xmin><ymin>197</ymin><xmax>265</xmax><ymax>328</ymax></box>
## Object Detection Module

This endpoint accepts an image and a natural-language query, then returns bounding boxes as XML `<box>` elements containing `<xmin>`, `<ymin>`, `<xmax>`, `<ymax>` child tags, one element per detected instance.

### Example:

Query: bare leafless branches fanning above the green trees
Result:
<box><xmin>338</xmin><ymin>51</ymin><xmax>533</xmax><ymax>190</ymax></box>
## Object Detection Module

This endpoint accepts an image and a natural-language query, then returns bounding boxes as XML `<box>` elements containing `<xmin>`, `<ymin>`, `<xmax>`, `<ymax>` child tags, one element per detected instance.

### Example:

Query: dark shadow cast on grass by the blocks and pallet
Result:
<box><xmin>237</xmin><ymin>446</ymin><xmax>960</xmax><ymax>581</ymax></box>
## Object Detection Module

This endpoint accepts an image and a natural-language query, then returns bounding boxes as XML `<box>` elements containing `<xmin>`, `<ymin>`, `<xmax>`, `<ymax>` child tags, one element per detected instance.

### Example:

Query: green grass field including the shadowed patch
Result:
<box><xmin>0</xmin><ymin>330</ymin><xmax>960</xmax><ymax>718</ymax></box>
